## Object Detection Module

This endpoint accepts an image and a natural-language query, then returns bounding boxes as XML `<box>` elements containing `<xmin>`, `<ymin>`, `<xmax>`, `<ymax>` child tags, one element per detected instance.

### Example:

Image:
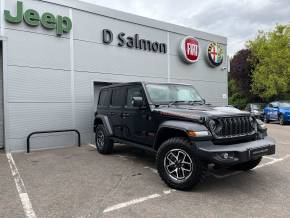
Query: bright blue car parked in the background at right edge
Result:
<box><xmin>264</xmin><ymin>101</ymin><xmax>290</xmax><ymax>125</ymax></box>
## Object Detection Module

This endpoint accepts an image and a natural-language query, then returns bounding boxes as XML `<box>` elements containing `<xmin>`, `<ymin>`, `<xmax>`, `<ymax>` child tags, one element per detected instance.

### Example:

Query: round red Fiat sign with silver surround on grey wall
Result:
<box><xmin>179</xmin><ymin>36</ymin><xmax>199</xmax><ymax>64</ymax></box>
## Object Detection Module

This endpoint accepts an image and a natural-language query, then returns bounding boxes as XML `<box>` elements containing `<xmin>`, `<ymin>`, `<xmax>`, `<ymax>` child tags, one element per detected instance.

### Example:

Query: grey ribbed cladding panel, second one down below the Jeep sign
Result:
<box><xmin>7</xmin><ymin>66</ymin><xmax>71</xmax><ymax>102</ymax></box>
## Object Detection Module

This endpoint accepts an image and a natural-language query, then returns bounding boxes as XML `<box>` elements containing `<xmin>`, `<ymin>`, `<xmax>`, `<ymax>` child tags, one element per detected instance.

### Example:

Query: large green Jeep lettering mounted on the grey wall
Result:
<box><xmin>4</xmin><ymin>1</ymin><xmax>72</xmax><ymax>36</ymax></box>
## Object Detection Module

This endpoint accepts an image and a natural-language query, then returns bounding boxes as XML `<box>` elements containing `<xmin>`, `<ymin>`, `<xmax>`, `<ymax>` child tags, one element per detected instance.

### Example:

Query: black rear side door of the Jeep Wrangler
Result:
<box><xmin>108</xmin><ymin>87</ymin><xmax>126</xmax><ymax>138</ymax></box>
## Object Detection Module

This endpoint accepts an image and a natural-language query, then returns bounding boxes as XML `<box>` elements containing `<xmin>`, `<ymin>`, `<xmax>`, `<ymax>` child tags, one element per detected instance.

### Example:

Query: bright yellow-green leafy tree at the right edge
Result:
<box><xmin>247</xmin><ymin>24</ymin><xmax>290</xmax><ymax>101</ymax></box>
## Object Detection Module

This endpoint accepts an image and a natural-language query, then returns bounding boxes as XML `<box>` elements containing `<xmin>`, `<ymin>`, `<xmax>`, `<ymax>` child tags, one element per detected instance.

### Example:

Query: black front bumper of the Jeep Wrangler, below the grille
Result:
<box><xmin>195</xmin><ymin>136</ymin><xmax>275</xmax><ymax>165</ymax></box>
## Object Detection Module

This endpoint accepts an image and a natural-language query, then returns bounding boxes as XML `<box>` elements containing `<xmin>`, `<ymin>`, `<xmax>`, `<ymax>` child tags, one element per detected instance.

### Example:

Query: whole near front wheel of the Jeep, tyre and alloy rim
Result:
<box><xmin>156</xmin><ymin>138</ymin><xmax>207</xmax><ymax>190</ymax></box>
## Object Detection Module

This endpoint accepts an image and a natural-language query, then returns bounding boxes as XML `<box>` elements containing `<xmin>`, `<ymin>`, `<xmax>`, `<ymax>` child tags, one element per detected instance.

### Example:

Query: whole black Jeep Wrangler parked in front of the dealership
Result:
<box><xmin>94</xmin><ymin>82</ymin><xmax>275</xmax><ymax>190</ymax></box>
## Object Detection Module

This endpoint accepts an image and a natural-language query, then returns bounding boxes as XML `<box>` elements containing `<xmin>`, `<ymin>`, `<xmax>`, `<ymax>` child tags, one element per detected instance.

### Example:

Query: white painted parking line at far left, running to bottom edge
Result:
<box><xmin>6</xmin><ymin>153</ymin><xmax>36</xmax><ymax>218</ymax></box>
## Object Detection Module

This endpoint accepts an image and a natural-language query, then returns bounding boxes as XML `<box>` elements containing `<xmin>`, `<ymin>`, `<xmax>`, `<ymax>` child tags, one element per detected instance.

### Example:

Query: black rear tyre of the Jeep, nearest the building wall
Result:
<box><xmin>95</xmin><ymin>124</ymin><xmax>114</xmax><ymax>154</ymax></box>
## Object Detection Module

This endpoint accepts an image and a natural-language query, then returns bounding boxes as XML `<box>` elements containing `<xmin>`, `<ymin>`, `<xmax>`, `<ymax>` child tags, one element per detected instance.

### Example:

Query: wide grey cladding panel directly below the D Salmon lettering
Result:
<box><xmin>74</xmin><ymin>40</ymin><xmax>167</xmax><ymax>77</ymax></box>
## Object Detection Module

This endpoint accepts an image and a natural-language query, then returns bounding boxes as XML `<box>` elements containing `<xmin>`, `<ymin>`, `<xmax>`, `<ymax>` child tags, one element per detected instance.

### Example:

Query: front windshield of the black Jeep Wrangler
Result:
<box><xmin>146</xmin><ymin>84</ymin><xmax>203</xmax><ymax>104</ymax></box>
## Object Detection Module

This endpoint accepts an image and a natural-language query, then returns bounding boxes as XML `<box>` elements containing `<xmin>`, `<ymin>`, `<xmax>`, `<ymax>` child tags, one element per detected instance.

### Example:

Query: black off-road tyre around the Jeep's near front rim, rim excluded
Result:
<box><xmin>156</xmin><ymin>137</ymin><xmax>207</xmax><ymax>190</ymax></box>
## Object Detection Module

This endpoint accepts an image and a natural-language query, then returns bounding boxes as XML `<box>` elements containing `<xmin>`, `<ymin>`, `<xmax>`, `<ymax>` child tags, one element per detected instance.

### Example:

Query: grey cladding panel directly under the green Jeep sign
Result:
<box><xmin>6</xmin><ymin>30</ymin><xmax>70</xmax><ymax>70</ymax></box>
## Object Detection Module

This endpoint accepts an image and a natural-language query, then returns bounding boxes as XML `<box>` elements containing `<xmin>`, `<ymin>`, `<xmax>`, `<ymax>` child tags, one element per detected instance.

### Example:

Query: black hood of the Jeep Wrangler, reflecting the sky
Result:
<box><xmin>153</xmin><ymin>105</ymin><xmax>250</xmax><ymax>120</ymax></box>
